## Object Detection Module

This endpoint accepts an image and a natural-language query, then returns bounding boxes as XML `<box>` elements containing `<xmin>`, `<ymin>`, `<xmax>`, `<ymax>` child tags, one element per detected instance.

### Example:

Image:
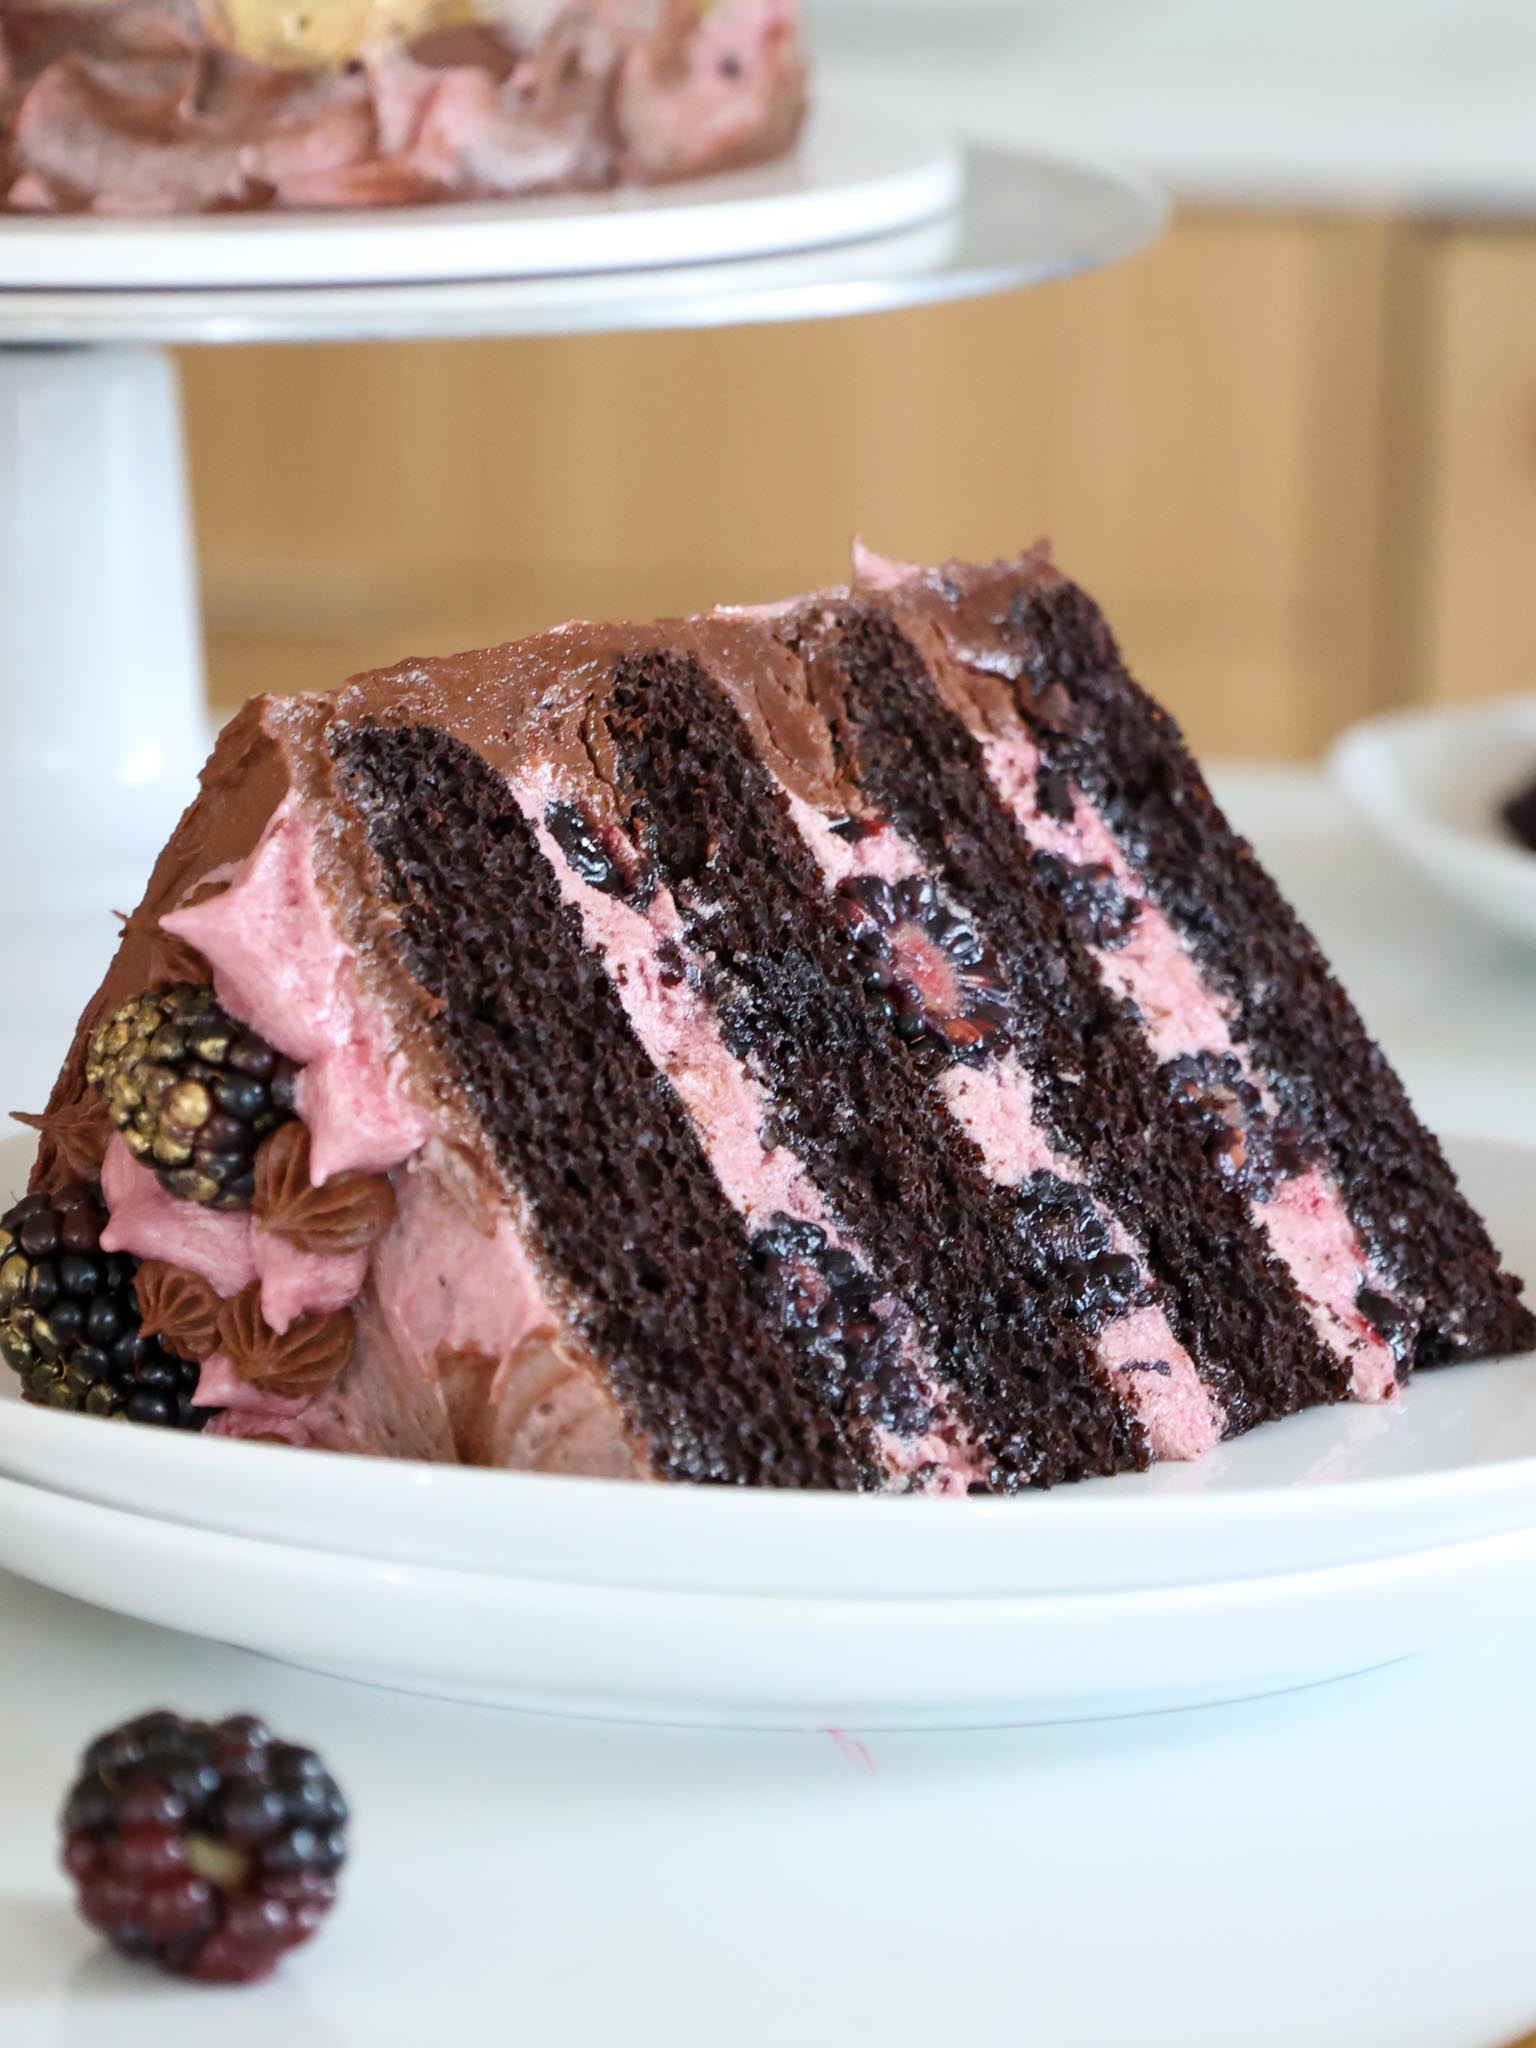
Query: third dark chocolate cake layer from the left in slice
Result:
<box><xmin>786</xmin><ymin>604</ymin><xmax>1348</xmax><ymax>1432</ymax></box>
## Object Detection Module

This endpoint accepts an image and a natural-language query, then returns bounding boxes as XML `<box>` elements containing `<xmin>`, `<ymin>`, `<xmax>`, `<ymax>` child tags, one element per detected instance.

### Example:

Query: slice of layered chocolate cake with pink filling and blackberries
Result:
<box><xmin>0</xmin><ymin>551</ymin><xmax>1536</xmax><ymax>1493</ymax></box>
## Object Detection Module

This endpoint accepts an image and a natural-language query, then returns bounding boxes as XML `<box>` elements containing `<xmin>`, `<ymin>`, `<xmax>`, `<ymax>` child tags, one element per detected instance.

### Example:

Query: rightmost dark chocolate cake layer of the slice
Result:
<box><xmin>921</xmin><ymin>573</ymin><xmax>1536</xmax><ymax>1366</ymax></box>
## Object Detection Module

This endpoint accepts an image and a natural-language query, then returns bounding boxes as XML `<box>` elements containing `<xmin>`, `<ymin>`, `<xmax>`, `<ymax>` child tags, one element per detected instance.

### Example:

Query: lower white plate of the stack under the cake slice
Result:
<box><xmin>0</xmin><ymin>1481</ymin><xmax>1536</xmax><ymax>1731</ymax></box>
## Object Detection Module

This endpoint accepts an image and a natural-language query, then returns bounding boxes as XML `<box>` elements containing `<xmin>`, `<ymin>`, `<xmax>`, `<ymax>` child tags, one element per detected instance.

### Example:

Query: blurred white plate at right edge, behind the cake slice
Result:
<box><xmin>1329</xmin><ymin>696</ymin><xmax>1536</xmax><ymax>938</ymax></box>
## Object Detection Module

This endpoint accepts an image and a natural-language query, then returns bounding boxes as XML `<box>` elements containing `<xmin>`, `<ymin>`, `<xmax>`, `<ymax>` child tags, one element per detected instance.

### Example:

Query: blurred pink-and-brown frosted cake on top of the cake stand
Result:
<box><xmin>0</xmin><ymin>0</ymin><xmax>805</xmax><ymax>215</ymax></box>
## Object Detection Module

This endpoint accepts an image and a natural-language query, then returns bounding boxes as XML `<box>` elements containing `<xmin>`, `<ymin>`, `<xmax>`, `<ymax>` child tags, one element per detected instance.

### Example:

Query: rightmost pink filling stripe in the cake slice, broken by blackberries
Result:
<box><xmin>977</xmin><ymin>735</ymin><xmax>1397</xmax><ymax>1401</ymax></box>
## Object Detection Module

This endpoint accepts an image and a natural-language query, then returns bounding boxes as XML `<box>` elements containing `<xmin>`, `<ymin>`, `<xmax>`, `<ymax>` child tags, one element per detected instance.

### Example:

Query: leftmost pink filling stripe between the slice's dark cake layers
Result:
<box><xmin>512</xmin><ymin>764</ymin><xmax>985</xmax><ymax>1493</ymax></box>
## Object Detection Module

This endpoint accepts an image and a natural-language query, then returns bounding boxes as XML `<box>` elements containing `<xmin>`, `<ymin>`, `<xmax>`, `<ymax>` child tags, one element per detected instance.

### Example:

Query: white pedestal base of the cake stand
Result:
<box><xmin>0</xmin><ymin>348</ymin><xmax>209</xmax><ymax>918</ymax></box>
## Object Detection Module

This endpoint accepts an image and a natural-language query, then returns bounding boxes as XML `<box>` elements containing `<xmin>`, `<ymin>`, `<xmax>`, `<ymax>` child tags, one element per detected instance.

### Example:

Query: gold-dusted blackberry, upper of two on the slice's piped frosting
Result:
<box><xmin>86</xmin><ymin>981</ymin><xmax>297</xmax><ymax>1208</ymax></box>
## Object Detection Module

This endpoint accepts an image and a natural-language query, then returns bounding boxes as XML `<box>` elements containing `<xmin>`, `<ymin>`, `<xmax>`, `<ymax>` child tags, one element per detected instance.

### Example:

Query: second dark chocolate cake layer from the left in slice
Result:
<box><xmin>606</xmin><ymin>653</ymin><xmax>1147</xmax><ymax>1491</ymax></box>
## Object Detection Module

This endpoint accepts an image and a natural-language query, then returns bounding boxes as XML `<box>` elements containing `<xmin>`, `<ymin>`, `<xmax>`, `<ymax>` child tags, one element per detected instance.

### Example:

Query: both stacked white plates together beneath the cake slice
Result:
<box><xmin>0</xmin><ymin>1145</ymin><xmax>1536</xmax><ymax>1731</ymax></box>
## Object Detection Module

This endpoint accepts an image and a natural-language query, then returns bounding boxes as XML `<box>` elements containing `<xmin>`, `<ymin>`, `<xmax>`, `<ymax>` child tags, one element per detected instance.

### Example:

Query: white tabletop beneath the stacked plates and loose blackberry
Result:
<box><xmin>0</xmin><ymin>772</ymin><xmax>1536</xmax><ymax>2048</ymax></box>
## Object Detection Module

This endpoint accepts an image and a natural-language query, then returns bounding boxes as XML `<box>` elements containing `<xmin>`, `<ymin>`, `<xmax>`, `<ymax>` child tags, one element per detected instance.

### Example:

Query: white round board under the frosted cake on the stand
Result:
<box><xmin>0</xmin><ymin>100</ymin><xmax>965</xmax><ymax>291</ymax></box>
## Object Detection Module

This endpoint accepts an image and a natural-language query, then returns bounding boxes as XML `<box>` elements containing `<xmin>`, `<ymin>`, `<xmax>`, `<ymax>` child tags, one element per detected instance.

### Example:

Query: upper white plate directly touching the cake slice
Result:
<box><xmin>0</xmin><ymin>1141</ymin><xmax>1536</xmax><ymax>1599</ymax></box>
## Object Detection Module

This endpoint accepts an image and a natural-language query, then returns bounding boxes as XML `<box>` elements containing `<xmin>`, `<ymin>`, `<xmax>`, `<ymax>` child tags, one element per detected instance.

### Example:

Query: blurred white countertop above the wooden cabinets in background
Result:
<box><xmin>831</xmin><ymin>0</ymin><xmax>1536</xmax><ymax>217</ymax></box>
